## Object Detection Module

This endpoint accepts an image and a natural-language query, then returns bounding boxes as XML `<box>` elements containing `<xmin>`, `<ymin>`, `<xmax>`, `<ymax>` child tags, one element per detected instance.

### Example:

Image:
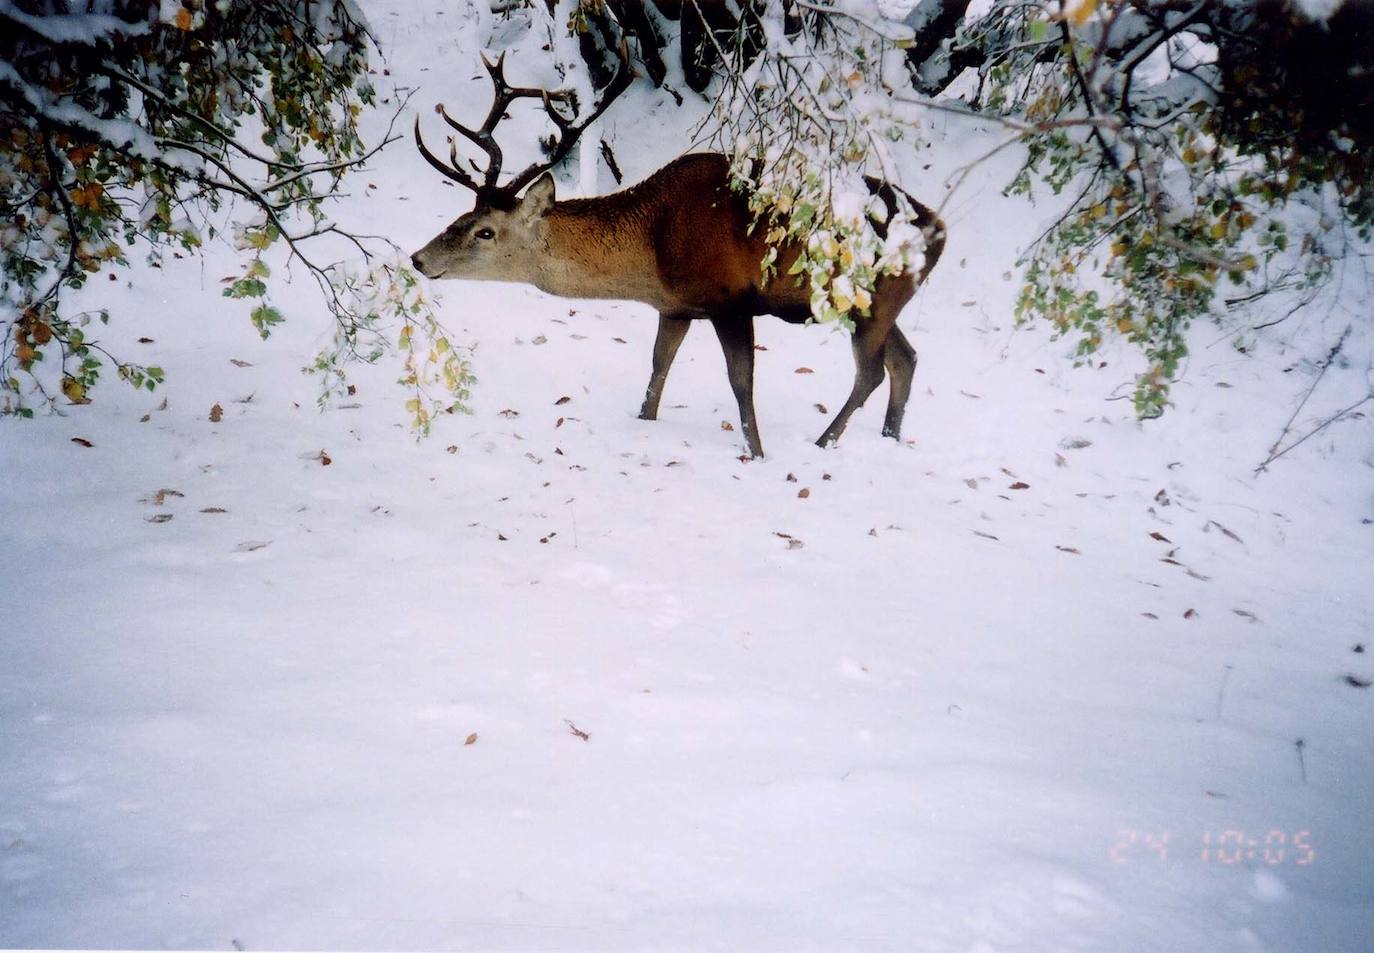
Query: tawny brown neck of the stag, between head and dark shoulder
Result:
<box><xmin>534</xmin><ymin>199</ymin><xmax>662</xmax><ymax>303</ymax></box>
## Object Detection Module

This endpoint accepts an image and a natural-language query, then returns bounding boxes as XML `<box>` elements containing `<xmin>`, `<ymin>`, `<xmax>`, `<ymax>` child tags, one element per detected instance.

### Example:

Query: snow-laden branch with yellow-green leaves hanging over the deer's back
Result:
<box><xmin>706</xmin><ymin>3</ymin><xmax>925</xmax><ymax>327</ymax></box>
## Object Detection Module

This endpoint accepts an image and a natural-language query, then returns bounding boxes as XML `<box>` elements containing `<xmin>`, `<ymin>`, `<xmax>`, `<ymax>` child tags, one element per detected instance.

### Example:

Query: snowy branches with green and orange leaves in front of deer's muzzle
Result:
<box><xmin>0</xmin><ymin>0</ymin><xmax>469</xmax><ymax>425</ymax></box>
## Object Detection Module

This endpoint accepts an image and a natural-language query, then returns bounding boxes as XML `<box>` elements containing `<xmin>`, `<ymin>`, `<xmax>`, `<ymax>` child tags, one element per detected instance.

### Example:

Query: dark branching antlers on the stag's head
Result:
<box><xmin>415</xmin><ymin>41</ymin><xmax>635</xmax><ymax>196</ymax></box>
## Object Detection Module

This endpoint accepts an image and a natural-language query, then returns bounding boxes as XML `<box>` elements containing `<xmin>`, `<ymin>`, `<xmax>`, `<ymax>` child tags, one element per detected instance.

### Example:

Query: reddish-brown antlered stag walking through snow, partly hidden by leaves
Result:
<box><xmin>411</xmin><ymin>56</ymin><xmax>945</xmax><ymax>457</ymax></box>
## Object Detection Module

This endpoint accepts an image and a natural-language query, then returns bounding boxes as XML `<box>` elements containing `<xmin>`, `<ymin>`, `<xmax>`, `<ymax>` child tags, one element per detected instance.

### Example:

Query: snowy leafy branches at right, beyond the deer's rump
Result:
<box><xmin>965</xmin><ymin>0</ymin><xmax>1374</xmax><ymax>417</ymax></box>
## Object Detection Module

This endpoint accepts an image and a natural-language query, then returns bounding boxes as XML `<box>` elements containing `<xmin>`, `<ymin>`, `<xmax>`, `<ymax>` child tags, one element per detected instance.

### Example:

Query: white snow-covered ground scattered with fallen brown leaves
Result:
<box><xmin>0</xmin><ymin>3</ymin><xmax>1374</xmax><ymax>953</ymax></box>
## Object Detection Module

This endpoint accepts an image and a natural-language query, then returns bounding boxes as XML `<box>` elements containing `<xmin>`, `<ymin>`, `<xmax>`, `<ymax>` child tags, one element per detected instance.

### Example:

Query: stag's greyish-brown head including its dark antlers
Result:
<box><xmin>411</xmin><ymin>45</ymin><xmax>633</xmax><ymax>282</ymax></box>
